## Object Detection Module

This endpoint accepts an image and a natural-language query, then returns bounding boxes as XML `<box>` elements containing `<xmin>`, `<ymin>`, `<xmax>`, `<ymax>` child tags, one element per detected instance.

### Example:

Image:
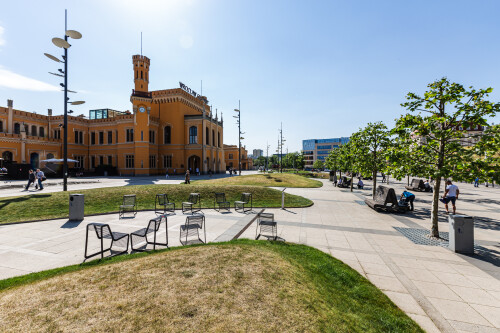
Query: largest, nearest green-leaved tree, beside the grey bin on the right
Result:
<box><xmin>393</xmin><ymin>78</ymin><xmax>500</xmax><ymax>237</ymax></box>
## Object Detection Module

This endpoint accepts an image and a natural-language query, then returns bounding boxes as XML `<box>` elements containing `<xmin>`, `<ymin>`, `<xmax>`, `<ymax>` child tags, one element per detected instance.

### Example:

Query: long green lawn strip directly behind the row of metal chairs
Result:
<box><xmin>0</xmin><ymin>184</ymin><xmax>312</xmax><ymax>224</ymax></box>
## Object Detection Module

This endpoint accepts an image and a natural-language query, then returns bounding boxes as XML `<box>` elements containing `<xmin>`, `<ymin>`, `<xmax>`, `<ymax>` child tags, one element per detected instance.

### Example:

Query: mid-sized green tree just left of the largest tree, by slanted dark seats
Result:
<box><xmin>350</xmin><ymin>122</ymin><xmax>390</xmax><ymax>197</ymax></box>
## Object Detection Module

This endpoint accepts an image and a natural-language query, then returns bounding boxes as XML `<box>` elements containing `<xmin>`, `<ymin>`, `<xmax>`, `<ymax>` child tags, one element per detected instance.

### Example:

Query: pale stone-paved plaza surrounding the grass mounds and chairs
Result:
<box><xmin>0</xmin><ymin>175</ymin><xmax>500</xmax><ymax>332</ymax></box>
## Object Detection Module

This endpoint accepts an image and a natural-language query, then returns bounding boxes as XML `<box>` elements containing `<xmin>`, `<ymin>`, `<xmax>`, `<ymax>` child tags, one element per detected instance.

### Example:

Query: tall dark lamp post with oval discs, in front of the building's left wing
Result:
<box><xmin>44</xmin><ymin>10</ymin><xmax>85</xmax><ymax>191</ymax></box>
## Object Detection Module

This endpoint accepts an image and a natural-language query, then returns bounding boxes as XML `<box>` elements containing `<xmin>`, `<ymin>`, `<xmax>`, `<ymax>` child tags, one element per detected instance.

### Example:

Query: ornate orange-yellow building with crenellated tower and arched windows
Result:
<box><xmin>0</xmin><ymin>55</ymin><xmax>226</xmax><ymax>175</ymax></box>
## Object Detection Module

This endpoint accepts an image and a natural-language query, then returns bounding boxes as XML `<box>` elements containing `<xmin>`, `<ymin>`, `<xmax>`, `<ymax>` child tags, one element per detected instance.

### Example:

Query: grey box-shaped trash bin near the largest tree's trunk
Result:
<box><xmin>448</xmin><ymin>215</ymin><xmax>474</xmax><ymax>253</ymax></box>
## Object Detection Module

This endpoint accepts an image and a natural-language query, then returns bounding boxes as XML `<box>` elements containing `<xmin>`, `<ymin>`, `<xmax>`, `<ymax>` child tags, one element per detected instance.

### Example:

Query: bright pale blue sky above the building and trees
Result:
<box><xmin>0</xmin><ymin>0</ymin><xmax>500</xmax><ymax>154</ymax></box>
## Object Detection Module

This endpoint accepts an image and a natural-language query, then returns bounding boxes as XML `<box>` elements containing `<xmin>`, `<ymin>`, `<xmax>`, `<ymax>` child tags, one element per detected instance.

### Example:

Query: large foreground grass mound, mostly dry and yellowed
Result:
<box><xmin>0</xmin><ymin>240</ymin><xmax>423</xmax><ymax>332</ymax></box>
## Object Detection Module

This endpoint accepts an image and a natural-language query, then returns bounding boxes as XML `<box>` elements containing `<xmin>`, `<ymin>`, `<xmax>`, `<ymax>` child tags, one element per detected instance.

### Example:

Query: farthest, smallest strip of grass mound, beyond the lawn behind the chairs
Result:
<box><xmin>196</xmin><ymin>173</ymin><xmax>323</xmax><ymax>187</ymax></box>
